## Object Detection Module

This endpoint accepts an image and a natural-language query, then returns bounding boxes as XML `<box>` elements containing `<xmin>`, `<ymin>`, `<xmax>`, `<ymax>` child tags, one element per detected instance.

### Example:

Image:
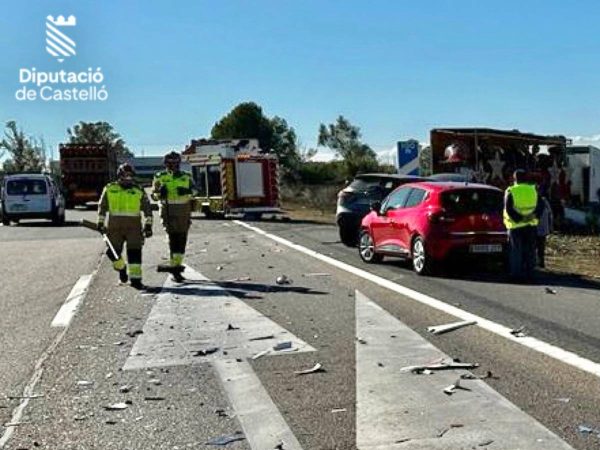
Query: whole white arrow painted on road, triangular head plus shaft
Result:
<box><xmin>123</xmin><ymin>267</ymin><xmax>315</xmax><ymax>450</ymax></box>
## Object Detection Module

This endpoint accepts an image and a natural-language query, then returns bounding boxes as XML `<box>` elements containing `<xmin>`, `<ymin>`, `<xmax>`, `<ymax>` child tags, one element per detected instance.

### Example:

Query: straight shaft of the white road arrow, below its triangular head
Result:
<box><xmin>214</xmin><ymin>359</ymin><xmax>302</xmax><ymax>450</ymax></box>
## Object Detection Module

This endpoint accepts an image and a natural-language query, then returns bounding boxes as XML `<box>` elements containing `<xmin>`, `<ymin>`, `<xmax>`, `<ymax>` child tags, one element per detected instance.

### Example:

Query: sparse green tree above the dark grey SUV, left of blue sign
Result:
<box><xmin>318</xmin><ymin>116</ymin><xmax>379</xmax><ymax>177</ymax></box>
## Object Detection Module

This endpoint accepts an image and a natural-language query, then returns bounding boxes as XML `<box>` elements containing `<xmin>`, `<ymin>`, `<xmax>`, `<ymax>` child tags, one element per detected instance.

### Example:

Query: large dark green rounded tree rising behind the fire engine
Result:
<box><xmin>210</xmin><ymin>102</ymin><xmax>302</xmax><ymax>178</ymax></box>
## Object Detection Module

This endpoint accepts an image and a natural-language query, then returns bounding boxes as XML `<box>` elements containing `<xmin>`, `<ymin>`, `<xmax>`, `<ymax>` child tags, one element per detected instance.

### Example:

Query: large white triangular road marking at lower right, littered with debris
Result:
<box><xmin>355</xmin><ymin>291</ymin><xmax>571</xmax><ymax>450</ymax></box>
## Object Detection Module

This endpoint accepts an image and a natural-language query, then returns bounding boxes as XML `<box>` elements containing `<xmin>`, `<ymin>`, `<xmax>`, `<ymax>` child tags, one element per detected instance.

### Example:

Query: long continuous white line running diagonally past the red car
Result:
<box><xmin>233</xmin><ymin>220</ymin><xmax>600</xmax><ymax>377</ymax></box>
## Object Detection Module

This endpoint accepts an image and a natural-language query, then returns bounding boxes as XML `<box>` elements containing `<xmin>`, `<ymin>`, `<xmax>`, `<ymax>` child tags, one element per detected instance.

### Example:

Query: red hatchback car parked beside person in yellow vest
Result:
<box><xmin>358</xmin><ymin>182</ymin><xmax>507</xmax><ymax>275</ymax></box>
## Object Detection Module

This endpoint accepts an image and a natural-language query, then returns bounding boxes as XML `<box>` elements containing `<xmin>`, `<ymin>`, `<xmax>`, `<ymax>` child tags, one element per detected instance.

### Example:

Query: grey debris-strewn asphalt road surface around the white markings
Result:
<box><xmin>0</xmin><ymin>216</ymin><xmax>600</xmax><ymax>449</ymax></box>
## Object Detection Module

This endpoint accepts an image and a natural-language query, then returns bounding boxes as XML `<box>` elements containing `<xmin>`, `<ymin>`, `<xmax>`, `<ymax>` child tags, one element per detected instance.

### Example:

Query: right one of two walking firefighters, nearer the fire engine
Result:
<box><xmin>152</xmin><ymin>152</ymin><xmax>195</xmax><ymax>282</ymax></box>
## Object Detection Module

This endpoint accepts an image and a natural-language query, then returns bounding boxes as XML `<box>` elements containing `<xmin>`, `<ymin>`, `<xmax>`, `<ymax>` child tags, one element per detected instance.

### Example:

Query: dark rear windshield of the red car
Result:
<box><xmin>442</xmin><ymin>189</ymin><xmax>504</xmax><ymax>214</ymax></box>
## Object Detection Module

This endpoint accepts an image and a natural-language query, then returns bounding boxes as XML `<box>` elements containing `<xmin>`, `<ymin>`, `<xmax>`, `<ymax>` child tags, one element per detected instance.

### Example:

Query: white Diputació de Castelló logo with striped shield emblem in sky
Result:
<box><xmin>15</xmin><ymin>15</ymin><xmax>108</xmax><ymax>102</ymax></box>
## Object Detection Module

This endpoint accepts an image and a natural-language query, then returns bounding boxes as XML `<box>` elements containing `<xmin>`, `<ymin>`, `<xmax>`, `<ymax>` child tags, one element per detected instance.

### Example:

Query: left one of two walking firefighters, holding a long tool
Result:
<box><xmin>97</xmin><ymin>163</ymin><xmax>152</xmax><ymax>289</ymax></box>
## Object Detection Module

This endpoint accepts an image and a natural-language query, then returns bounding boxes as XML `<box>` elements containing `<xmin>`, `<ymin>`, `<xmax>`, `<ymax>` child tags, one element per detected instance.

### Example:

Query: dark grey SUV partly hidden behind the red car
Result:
<box><xmin>335</xmin><ymin>173</ymin><xmax>425</xmax><ymax>246</ymax></box>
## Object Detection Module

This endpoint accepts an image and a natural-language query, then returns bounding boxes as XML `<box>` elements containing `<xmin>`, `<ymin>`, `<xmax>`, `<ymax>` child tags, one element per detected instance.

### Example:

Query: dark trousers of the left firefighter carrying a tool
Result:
<box><xmin>106</xmin><ymin>213</ymin><xmax>144</xmax><ymax>280</ymax></box>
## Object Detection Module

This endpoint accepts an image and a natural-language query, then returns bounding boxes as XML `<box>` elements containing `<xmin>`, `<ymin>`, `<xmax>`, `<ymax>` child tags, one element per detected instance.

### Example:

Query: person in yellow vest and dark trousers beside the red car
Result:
<box><xmin>503</xmin><ymin>170</ymin><xmax>542</xmax><ymax>280</ymax></box>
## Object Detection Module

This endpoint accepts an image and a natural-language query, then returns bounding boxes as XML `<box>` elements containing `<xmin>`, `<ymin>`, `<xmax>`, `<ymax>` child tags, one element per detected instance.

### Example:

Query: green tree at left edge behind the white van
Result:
<box><xmin>0</xmin><ymin>120</ymin><xmax>46</xmax><ymax>173</ymax></box>
